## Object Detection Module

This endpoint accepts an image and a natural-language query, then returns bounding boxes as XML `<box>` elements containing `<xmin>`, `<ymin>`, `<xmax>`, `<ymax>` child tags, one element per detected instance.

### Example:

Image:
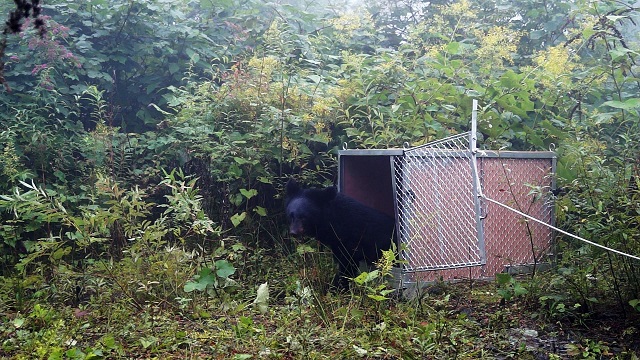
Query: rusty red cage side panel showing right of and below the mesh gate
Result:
<box><xmin>410</xmin><ymin>158</ymin><xmax>553</xmax><ymax>281</ymax></box>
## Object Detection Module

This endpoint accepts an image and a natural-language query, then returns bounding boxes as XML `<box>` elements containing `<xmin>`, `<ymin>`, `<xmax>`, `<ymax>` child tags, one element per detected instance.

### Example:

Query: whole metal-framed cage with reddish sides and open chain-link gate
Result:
<box><xmin>338</xmin><ymin>139</ymin><xmax>556</xmax><ymax>283</ymax></box>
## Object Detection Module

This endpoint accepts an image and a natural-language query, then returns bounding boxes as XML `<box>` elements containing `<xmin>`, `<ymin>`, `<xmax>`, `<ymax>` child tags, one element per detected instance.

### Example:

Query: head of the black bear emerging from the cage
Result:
<box><xmin>286</xmin><ymin>179</ymin><xmax>338</xmax><ymax>236</ymax></box>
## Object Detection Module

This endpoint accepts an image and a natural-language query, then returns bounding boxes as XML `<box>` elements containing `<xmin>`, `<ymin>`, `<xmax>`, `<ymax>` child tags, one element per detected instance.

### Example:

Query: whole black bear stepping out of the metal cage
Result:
<box><xmin>286</xmin><ymin>179</ymin><xmax>395</xmax><ymax>288</ymax></box>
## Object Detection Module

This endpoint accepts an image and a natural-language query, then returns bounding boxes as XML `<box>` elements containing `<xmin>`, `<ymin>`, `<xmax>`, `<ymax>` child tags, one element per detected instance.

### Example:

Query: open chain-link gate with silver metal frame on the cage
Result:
<box><xmin>394</xmin><ymin>132</ymin><xmax>486</xmax><ymax>273</ymax></box>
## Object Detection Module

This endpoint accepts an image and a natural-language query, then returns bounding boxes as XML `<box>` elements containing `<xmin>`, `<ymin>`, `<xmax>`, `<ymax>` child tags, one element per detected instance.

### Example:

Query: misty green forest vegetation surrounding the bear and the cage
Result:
<box><xmin>0</xmin><ymin>0</ymin><xmax>640</xmax><ymax>359</ymax></box>
